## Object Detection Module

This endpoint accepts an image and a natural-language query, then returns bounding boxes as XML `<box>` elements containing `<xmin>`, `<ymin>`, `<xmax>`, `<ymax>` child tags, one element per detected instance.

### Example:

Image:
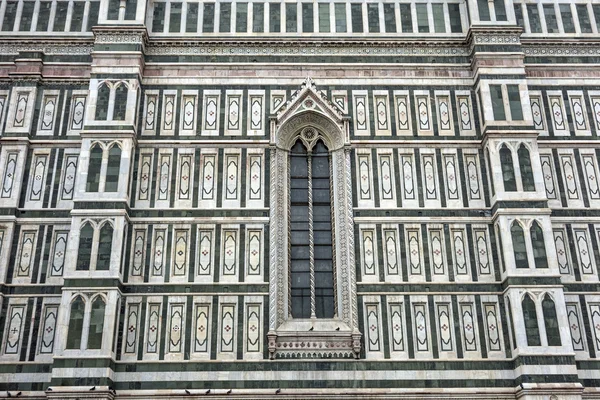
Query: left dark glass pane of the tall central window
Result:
<box><xmin>290</xmin><ymin>140</ymin><xmax>311</xmax><ymax>318</ymax></box>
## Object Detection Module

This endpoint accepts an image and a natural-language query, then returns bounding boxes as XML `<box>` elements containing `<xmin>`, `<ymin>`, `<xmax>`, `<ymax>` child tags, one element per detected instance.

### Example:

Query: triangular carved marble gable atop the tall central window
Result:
<box><xmin>276</xmin><ymin>77</ymin><xmax>344</xmax><ymax>126</ymax></box>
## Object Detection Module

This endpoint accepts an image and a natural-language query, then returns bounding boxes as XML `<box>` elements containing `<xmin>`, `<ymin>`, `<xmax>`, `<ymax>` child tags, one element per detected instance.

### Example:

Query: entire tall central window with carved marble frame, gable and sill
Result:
<box><xmin>267</xmin><ymin>79</ymin><xmax>361</xmax><ymax>358</ymax></box>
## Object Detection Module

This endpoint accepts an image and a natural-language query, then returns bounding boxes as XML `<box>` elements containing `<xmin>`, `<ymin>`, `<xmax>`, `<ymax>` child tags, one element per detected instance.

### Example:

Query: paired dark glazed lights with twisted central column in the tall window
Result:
<box><xmin>290</xmin><ymin>135</ymin><xmax>335</xmax><ymax>318</ymax></box>
